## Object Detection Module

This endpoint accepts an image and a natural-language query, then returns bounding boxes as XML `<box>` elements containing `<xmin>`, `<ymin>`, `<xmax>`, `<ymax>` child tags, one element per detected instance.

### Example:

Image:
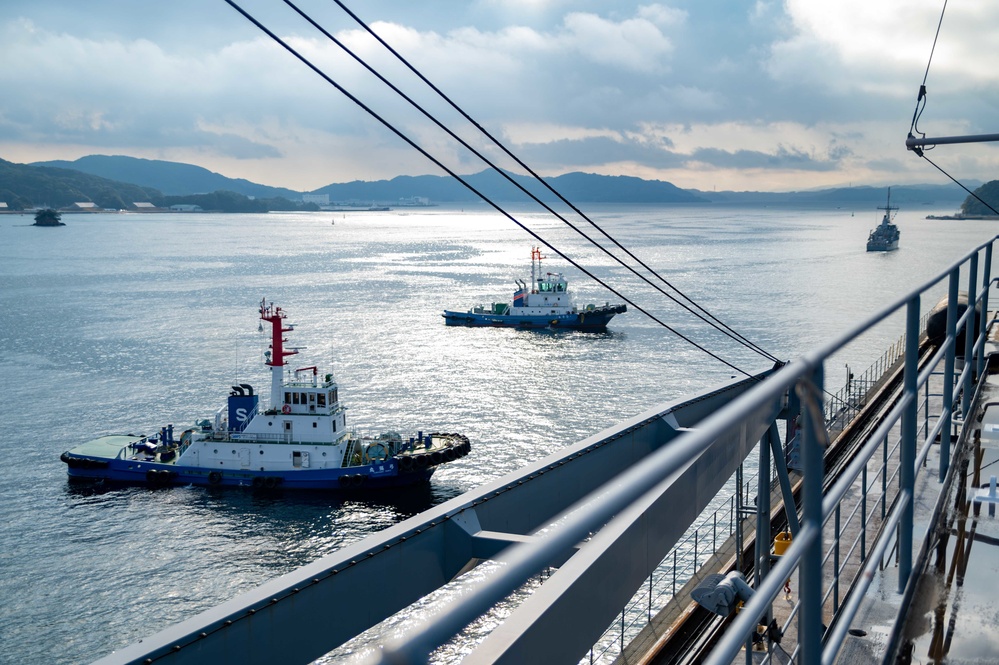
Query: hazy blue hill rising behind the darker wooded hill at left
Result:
<box><xmin>31</xmin><ymin>155</ymin><xmax>302</xmax><ymax>200</ymax></box>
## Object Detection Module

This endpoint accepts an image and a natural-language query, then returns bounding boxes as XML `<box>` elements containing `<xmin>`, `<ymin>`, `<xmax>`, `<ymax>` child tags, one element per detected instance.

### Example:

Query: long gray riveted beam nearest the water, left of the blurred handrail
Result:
<box><xmin>99</xmin><ymin>372</ymin><xmax>770</xmax><ymax>665</ymax></box>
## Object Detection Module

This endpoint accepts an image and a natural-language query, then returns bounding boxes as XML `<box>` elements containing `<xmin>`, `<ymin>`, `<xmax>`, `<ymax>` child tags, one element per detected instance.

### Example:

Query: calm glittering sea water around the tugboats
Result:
<box><xmin>0</xmin><ymin>206</ymin><xmax>999</xmax><ymax>663</ymax></box>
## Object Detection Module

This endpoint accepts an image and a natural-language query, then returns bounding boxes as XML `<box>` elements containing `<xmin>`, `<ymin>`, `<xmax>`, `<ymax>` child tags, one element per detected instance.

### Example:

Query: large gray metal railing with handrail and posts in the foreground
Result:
<box><xmin>380</xmin><ymin>236</ymin><xmax>999</xmax><ymax>664</ymax></box>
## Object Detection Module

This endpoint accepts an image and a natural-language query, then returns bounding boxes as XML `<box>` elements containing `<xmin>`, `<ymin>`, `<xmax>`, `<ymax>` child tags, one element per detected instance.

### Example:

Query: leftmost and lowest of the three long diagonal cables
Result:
<box><xmin>224</xmin><ymin>0</ymin><xmax>752</xmax><ymax>377</ymax></box>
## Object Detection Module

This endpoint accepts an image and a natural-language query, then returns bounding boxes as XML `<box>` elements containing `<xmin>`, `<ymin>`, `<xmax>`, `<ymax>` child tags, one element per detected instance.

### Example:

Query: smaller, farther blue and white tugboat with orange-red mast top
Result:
<box><xmin>444</xmin><ymin>247</ymin><xmax>628</xmax><ymax>331</ymax></box>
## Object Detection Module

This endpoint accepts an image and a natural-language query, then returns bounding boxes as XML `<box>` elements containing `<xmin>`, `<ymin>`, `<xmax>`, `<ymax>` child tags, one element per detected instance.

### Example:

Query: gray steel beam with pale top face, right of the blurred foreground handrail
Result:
<box><xmin>464</xmin><ymin>394</ymin><xmax>779</xmax><ymax>665</ymax></box>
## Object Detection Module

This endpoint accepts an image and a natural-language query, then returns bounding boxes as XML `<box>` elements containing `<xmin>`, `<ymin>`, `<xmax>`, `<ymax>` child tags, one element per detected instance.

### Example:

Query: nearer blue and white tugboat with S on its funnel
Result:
<box><xmin>61</xmin><ymin>301</ymin><xmax>471</xmax><ymax>490</ymax></box>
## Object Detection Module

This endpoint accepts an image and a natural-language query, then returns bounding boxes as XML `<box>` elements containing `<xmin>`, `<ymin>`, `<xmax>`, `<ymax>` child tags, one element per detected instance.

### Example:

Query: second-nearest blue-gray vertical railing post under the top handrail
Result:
<box><xmin>898</xmin><ymin>294</ymin><xmax>919</xmax><ymax>593</ymax></box>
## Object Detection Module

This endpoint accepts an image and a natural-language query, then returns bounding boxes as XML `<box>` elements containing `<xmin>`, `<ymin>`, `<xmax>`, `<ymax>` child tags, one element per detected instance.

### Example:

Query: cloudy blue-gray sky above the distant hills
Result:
<box><xmin>0</xmin><ymin>0</ymin><xmax>999</xmax><ymax>191</ymax></box>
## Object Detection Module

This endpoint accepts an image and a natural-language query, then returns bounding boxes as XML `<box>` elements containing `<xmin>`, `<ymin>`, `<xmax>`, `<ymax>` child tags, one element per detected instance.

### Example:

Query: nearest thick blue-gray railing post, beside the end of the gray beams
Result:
<box><xmin>798</xmin><ymin>365</ymin><xmax>825</xmax><ymax>663</ymax></box>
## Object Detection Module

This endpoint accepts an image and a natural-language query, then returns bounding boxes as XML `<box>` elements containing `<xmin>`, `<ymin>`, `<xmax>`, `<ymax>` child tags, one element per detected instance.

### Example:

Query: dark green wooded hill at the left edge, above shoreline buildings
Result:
<box><xmin>0</xmin><ymin>159</ymin><xmax>162</xmax><ymax>210</ymax></box>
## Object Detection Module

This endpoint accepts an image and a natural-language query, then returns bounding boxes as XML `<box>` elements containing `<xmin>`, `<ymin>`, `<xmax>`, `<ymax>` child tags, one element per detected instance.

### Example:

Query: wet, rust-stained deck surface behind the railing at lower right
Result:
<box><xmin>839</xmin><ymin>366</ymin><xmax>999</xmax><ymax>665</ymax></box>
